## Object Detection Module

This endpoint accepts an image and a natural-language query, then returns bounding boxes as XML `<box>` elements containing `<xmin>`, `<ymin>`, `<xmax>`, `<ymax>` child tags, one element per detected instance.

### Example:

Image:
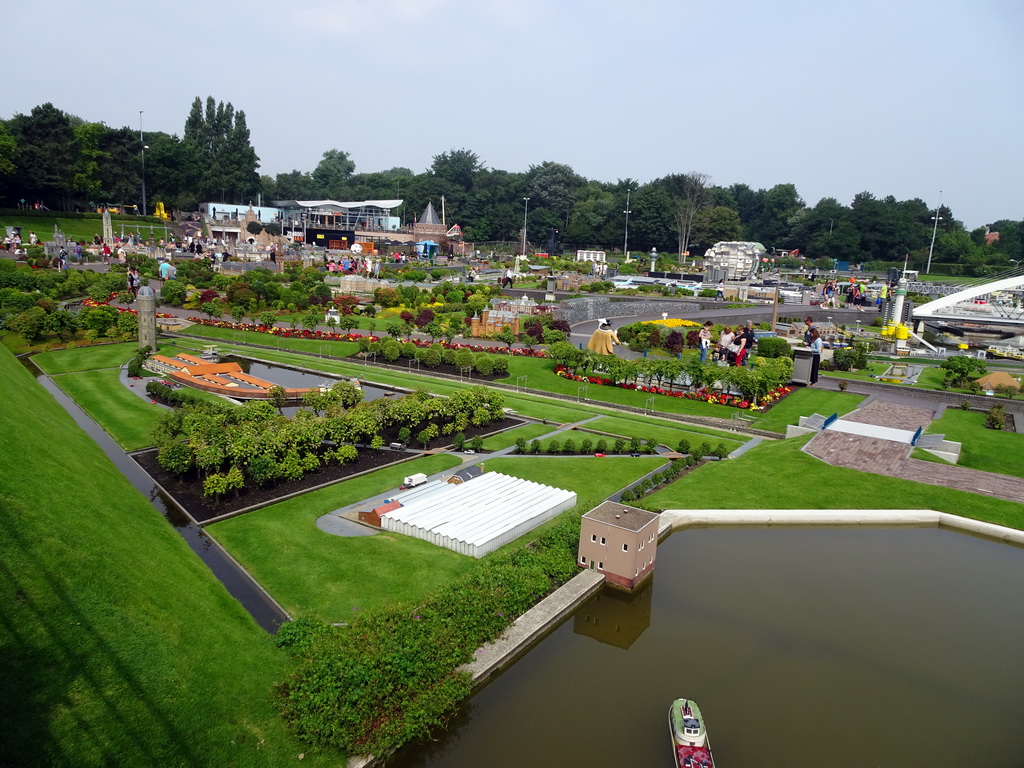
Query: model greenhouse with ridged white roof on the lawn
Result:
<box><xmin>381</xmin><ymin>472</ymin><xmax>577</xmax><ymax>557</ymax></box>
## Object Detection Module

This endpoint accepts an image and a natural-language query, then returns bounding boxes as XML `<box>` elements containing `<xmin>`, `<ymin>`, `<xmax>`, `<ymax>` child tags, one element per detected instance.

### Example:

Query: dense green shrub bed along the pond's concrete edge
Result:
<box><xmin>278</xmin><ymin>512</ymin><xmax>580</xmax><ymax>756</ymax></box>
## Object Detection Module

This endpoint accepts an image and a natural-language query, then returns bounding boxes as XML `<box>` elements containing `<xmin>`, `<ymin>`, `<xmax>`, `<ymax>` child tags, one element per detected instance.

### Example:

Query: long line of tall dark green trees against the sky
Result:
<box><xmin>0</xmin><ymin>96</ymin><xmax>1024</xmax><ymax>274</ymax></box>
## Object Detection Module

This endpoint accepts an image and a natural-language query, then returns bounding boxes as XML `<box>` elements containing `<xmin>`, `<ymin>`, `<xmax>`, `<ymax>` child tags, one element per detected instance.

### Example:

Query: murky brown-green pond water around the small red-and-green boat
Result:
<box><xmin>388</xmin><ymin>528</ymin><xmax>1024</xmax><ymax>768</ymax></box>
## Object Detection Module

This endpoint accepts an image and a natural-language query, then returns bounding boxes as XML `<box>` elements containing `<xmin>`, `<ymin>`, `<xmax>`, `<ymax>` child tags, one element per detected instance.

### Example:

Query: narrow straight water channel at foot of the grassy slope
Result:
<box><xmin>23</xmin><ymin>358</ymin><xmax>291</xmax><ymax>634</ymax></box>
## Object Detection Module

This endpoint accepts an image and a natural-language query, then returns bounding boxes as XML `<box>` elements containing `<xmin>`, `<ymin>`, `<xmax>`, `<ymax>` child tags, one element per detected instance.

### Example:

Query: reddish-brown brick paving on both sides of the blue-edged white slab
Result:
<box><xmin>804</xmin><ymin>396</ymin><xmax>1024</xmax><ymax>502</ymax></box>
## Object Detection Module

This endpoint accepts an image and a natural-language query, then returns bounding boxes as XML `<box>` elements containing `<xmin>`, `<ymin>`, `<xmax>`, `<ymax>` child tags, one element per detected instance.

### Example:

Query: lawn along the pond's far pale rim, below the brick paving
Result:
<box><xmin>644</xmin><ymin>437</ymin><xmax>1024</xmax><ymax>528</ymax></box>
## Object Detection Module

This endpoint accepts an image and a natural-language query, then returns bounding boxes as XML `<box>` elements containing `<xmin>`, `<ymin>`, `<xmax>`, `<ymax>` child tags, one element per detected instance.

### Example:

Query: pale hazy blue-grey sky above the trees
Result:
<box><xmin>0</xmin><ymin>0</ymin><xmax>1024</xmax><ymax>228</ymax></box>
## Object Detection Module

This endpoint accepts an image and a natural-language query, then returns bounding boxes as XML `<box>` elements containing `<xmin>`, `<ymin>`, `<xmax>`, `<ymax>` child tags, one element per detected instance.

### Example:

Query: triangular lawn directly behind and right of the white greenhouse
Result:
<box><xmin>485</xmin><ymin>456</ymin><xmax>668</xmax><ymax>512</ymax></box>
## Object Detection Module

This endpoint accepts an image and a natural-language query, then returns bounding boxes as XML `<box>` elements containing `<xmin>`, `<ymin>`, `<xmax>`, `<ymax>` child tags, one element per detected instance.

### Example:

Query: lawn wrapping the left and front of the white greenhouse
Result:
<box><xmin>206</xmin><ymin>455</ymin><xmax>464</xmax><ymax>622</ymax></box>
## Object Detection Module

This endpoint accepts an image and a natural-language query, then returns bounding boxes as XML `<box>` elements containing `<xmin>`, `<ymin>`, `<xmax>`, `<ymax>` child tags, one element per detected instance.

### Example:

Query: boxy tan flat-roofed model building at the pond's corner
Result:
<box><xmin>577</xmin><ymin>502</ymin><xmax>658</xmax><ymax>589</ymax></box>
